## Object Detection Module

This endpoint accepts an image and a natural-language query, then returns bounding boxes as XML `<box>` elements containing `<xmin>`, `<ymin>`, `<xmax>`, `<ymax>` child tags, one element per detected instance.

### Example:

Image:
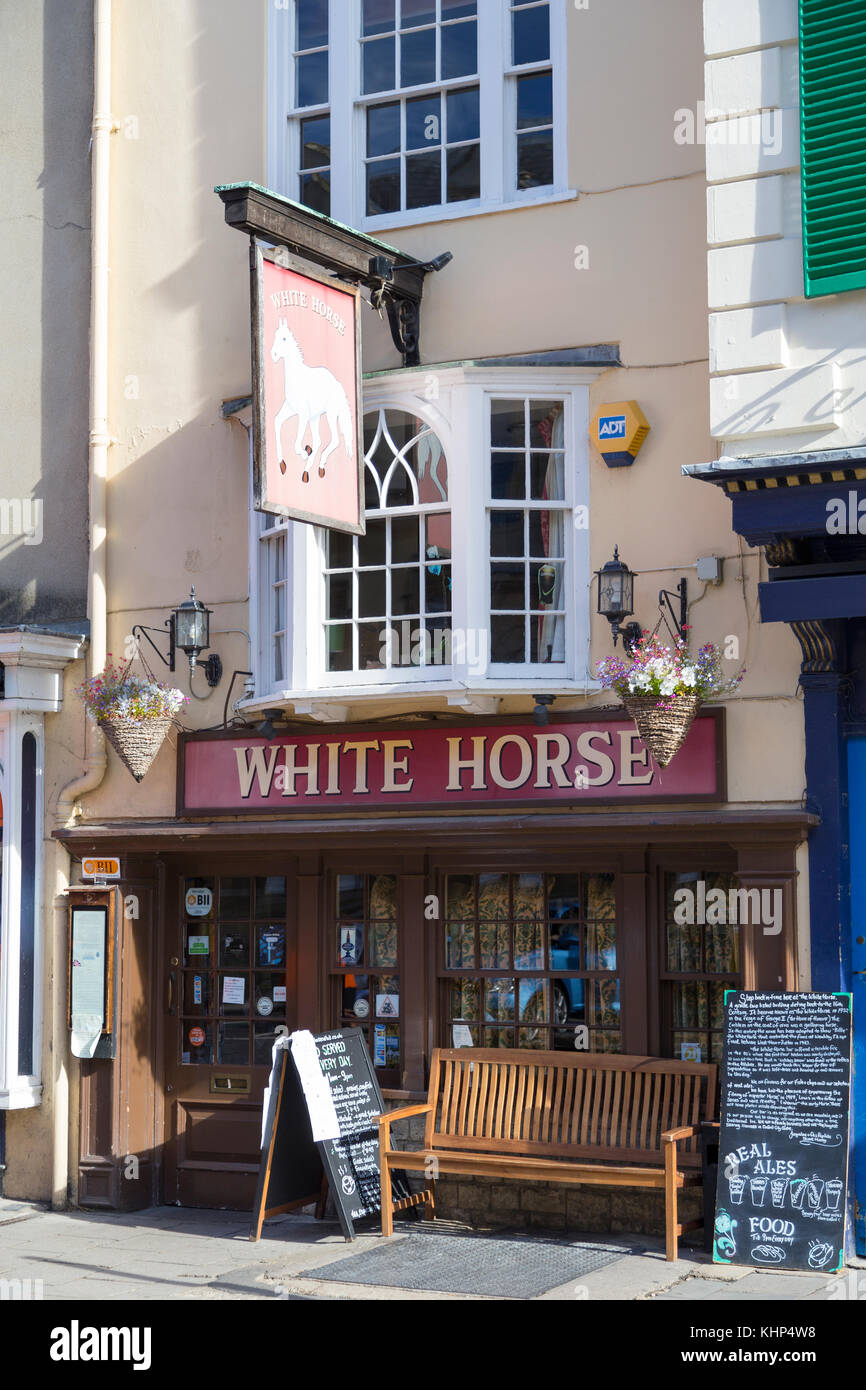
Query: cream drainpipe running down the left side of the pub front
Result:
<box><xmin>51</xmin><ymin>0</ymin><xmax>114</xmax><ymax>1208</ymax></box>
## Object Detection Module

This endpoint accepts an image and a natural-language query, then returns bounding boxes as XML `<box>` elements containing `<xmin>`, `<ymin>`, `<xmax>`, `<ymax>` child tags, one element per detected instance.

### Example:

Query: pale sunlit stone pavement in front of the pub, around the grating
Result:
<box><xmin>0</xmin><ymin>1198</ymin><xmax>866</xmax><ymax>1304</ymax></box>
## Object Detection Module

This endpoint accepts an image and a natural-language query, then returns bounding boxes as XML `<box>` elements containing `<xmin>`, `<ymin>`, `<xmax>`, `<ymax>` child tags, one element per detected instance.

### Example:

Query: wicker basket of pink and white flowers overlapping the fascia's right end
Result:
<box><xmin>596</xmin><ymin>632</ymin><xmax>745</xmax><ymax>767</ymax></box>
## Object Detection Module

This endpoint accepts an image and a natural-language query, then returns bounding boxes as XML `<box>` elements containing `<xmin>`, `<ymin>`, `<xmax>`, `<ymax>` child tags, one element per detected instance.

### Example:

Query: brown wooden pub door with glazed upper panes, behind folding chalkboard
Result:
<box><xmin>163</xmin><ymin>872</ymin><xmax>296</xmax><ymax>1211</ymax></box>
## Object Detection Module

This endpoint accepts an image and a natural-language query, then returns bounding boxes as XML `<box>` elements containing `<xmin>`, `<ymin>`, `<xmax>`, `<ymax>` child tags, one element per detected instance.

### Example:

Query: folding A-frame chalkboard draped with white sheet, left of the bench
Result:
<box><xmin>250</xmin><ymin>1029</ymin><xmax>423</xmax><ymax>1240</ymax></box>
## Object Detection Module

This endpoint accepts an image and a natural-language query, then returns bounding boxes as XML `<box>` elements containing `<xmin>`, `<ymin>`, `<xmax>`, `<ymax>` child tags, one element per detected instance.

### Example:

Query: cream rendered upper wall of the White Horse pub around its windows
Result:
<box><xmin>64</xmin><ymin>0</ymin><xmax>803</xmax><ymax>821</ymax></box>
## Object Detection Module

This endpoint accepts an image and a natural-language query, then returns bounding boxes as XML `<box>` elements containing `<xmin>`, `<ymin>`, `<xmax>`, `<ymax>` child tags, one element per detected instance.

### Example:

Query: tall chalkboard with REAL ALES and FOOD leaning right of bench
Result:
<box><xmin>713</xmin><ymin>991</ymin><xmax>851</xmax><ymax>1273</ymax></box>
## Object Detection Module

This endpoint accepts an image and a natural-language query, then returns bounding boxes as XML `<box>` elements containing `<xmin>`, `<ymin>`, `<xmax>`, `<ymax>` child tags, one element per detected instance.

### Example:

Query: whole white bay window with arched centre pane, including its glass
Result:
<box><xmin>256</xmin><ymin>367</ymin><xmax>596</xmax><ymax>705</ymax></box>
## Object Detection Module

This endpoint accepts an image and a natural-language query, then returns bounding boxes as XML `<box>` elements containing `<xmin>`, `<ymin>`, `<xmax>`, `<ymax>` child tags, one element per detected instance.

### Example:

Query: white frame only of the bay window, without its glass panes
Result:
<box><xmin>250</xmin><ymin>367</ymin><xmax>599</xmax><ymax>713</ymax></box>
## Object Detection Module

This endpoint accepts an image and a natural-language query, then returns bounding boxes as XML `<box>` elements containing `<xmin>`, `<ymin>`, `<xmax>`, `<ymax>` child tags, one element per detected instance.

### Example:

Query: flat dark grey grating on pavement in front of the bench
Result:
<box><xmin>299</xmin><ymin>1232</ymin><xmax>631</xmax><ymax>1298</ymax></box>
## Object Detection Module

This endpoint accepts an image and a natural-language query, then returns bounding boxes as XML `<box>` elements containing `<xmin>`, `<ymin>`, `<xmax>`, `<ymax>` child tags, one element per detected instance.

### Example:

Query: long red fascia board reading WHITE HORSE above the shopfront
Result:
<box><xmin>178</xmin><ymin>709</ymin><xmax>726</xmax><ymax>816</ymax></box>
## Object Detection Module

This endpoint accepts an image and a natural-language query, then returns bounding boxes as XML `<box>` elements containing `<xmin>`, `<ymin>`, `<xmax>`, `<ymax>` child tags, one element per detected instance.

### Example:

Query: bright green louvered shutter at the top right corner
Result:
<box><xmin>799</xmin><ymin>0</ymin><xmax>866</xmax><ymax>296</ymax></box>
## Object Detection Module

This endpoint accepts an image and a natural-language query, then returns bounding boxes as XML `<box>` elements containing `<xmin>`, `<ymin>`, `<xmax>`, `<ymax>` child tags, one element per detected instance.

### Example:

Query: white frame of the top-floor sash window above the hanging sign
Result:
<box><xmin>267</xmin><ymin>0</ymin><xmax>577</xmax><ymax>235</ymax></box>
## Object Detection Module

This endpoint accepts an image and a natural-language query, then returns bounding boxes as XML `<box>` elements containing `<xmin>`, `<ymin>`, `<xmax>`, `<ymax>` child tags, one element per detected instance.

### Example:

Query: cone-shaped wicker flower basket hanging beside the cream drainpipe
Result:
<box><xmin>75</xmin><ymin>653</ymin><xmax>189</xmax><ymax>783</ymax></box>
